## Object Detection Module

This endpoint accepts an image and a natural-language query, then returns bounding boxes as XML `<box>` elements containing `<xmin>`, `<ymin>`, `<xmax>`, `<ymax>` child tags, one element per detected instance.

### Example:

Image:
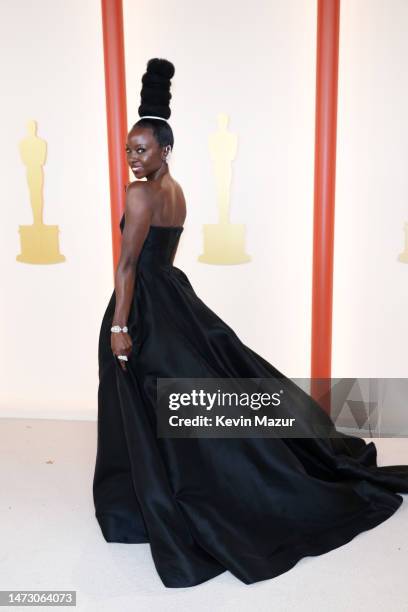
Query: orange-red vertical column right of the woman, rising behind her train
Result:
<box><xmin>311</xmin><ymin>0</ymin><xmax>340</xmax><ymax>411</ymax></box>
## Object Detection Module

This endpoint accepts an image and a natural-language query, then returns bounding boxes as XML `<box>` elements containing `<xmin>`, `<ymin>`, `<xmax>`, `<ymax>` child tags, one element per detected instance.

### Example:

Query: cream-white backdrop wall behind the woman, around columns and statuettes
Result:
<box><xmin>0</xmin><ymin>0</ymin><xmax>408</xmax><ymax>419</ymax></box>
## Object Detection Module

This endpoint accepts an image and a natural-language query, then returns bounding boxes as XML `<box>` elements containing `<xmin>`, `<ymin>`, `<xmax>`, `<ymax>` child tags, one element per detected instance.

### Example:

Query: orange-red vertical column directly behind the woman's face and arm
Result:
<box><xmin>101</xmin><ymin>0</ymin><xmax>129</xmax><ymax>272</ymax></box>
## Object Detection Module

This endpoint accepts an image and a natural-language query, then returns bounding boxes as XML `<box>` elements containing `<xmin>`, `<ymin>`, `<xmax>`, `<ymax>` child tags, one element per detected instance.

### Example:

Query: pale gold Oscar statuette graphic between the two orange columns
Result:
<box><xmin>198</xmin><ymin>113</ymin><xmax>251</xmax><ymax>264</ymax></box>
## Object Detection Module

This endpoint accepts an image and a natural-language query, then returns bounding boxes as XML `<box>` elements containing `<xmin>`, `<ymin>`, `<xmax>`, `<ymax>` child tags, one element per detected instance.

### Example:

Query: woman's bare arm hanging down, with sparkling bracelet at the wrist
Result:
<box><xmin>111</xmin><ymin>181</ymin><xmax>152</xmax><ymax>370</ymax></box>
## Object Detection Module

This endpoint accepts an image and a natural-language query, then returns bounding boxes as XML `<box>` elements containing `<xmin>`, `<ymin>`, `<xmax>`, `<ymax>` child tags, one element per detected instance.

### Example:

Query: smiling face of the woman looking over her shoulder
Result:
<box><xmin>126</xmin><ymin>128</ymin><xmax>167</xmax><ymax>179</ymax></box>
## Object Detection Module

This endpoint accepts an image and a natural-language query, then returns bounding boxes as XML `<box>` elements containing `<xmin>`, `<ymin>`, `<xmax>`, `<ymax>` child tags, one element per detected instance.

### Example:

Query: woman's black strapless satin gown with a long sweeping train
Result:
<box><xmin>93</xmin><ymin>218</ymin><xmax>408</xmax><ymax>587</ymax></box>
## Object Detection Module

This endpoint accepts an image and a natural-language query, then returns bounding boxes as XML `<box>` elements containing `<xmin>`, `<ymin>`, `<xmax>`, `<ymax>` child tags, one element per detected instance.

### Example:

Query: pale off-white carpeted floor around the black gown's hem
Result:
<box><xmin>0</xmin><ymin>418</ymin><xmax>408</xmax><ymax>612</ymax></box>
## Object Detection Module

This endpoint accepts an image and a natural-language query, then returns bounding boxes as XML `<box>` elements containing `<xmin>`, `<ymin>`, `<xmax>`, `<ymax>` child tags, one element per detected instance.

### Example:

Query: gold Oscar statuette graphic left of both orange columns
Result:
<box><xmin>16</xmin><ymin>120</ymin><xmax>65</xmax><ymax>264</ymax></box>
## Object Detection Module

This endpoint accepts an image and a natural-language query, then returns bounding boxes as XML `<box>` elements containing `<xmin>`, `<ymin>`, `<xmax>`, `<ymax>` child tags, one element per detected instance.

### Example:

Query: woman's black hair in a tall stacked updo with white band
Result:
<box><xmin>132</xmin><ymin>57</ymin><xmax>175</xmax><ymax>148</ymax></box>
